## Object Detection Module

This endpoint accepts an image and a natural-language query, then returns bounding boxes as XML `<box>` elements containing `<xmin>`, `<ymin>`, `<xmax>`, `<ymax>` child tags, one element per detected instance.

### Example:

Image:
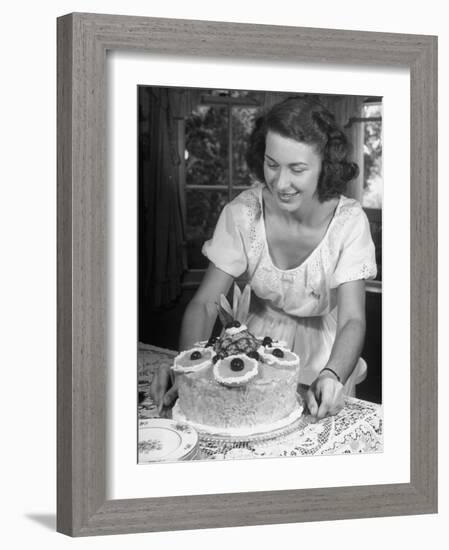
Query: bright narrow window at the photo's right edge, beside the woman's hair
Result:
<box><xmin>362</xmin><ymin>103</ymin><xmax>383</xmax><ymax>208</ymax></box>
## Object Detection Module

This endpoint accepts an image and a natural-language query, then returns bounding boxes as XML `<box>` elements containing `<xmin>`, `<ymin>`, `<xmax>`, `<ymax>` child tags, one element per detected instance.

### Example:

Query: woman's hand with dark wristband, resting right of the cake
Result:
<box><xmin>306</xmin><ymin>371</ymin><xmax>345</xmax><ymax>421</ymax></box>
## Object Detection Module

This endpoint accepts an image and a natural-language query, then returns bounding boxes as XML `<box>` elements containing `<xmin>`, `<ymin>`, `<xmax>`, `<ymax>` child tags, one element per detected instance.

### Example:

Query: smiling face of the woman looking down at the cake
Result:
<box><xmin>264</xmin><ymin>131</ymin><xmax>321</xmax><ymax>212</ymax></box>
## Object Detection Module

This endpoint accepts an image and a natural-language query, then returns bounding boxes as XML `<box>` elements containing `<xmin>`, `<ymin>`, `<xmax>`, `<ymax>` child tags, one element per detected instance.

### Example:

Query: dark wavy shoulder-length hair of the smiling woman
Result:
<box><xmin>246</xmin><ymin>96</ymin><xmax>359</xmax><ymax>202</ymax></box>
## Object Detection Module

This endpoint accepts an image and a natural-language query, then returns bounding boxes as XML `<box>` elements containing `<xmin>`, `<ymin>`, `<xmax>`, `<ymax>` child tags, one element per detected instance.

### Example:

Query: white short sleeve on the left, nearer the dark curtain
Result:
<box><xmin>201</xmin><ymin>202</ymin><xmax>248</xmax><ymax>277</ymax></box>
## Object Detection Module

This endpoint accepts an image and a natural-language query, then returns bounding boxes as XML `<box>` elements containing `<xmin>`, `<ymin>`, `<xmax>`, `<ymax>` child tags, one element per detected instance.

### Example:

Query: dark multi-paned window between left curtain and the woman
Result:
<box><xmin>180</xmin><ymin>90</ymin><xmax>258</xmax><ymax>275</ymax></box>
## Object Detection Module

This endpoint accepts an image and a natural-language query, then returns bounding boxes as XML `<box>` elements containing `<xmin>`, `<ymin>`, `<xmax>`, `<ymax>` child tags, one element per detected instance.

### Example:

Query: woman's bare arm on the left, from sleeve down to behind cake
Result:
<box><xmin>179</xmin><ymin>263</ymin><xmax>234</xmax><ymax>351</ymax></box>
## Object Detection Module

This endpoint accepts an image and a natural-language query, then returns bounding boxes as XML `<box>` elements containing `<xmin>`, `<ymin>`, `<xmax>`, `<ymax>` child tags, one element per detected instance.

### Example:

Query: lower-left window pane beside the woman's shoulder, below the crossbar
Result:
<box><xmin>186</xmin><ymin>189</ymin><xmax>228</xmax><ymax>269</ymax></box>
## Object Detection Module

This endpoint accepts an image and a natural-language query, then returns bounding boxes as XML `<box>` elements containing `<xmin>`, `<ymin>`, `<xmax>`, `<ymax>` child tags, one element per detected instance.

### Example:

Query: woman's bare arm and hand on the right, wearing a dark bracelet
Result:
<box><xmin>306</xmin><ymin>280</ymin><xmax>366</xmax><ymax>420</ymax></box>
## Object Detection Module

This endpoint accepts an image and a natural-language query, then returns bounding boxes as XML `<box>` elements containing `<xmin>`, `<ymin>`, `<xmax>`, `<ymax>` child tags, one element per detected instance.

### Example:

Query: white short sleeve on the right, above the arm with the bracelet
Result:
<box><xmin>331</xmin><ymin>203</ymin><xmax>377</xmax><ymax>288</ymax></box>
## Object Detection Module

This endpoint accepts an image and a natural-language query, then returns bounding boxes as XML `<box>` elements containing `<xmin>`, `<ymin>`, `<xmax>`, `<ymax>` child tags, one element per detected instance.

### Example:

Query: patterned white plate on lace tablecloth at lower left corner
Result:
<box><xmin>138</xmin><ymin>418</ymin><xmax>198</xmax><ymax>464</ymax></box>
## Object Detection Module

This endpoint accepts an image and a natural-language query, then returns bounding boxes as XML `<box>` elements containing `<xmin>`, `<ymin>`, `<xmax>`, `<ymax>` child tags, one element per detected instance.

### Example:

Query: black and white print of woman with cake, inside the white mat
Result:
<box><xmin>137</xmin><ymin>85</ymin><xmax>383</xmax><ymax>464</ymax></box>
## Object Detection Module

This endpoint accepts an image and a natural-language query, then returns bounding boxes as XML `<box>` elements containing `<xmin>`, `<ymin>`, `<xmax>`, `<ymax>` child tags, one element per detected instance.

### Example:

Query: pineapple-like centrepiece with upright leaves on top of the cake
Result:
<box><xmin>214</xmin><ymin>283</ymin><xmax>261</xmax><ymax>357</ymax></box>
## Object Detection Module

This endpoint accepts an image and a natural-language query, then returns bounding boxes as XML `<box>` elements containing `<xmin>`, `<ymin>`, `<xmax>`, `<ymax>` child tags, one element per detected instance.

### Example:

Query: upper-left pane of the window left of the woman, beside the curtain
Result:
<box><xmin>185</xmin><ymin>106</ymin><xmax>229</xmax><ymax>185</ymax></box>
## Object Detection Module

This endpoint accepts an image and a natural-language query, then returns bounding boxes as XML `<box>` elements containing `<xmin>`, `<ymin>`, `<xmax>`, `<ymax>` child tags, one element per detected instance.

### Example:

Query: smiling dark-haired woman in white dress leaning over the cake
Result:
<box><xmin>152</xmin><ymin>98</ymin><xmax>376</xmax><ymax>419</ymax></box>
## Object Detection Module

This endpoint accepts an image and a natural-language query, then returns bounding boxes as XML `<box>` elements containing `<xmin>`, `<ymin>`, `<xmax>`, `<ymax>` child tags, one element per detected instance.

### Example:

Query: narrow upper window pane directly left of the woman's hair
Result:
<box><xmin>232</xmin><ymin>107</ymin><xmax>257</xmax><ymax>186</ymax></box>
